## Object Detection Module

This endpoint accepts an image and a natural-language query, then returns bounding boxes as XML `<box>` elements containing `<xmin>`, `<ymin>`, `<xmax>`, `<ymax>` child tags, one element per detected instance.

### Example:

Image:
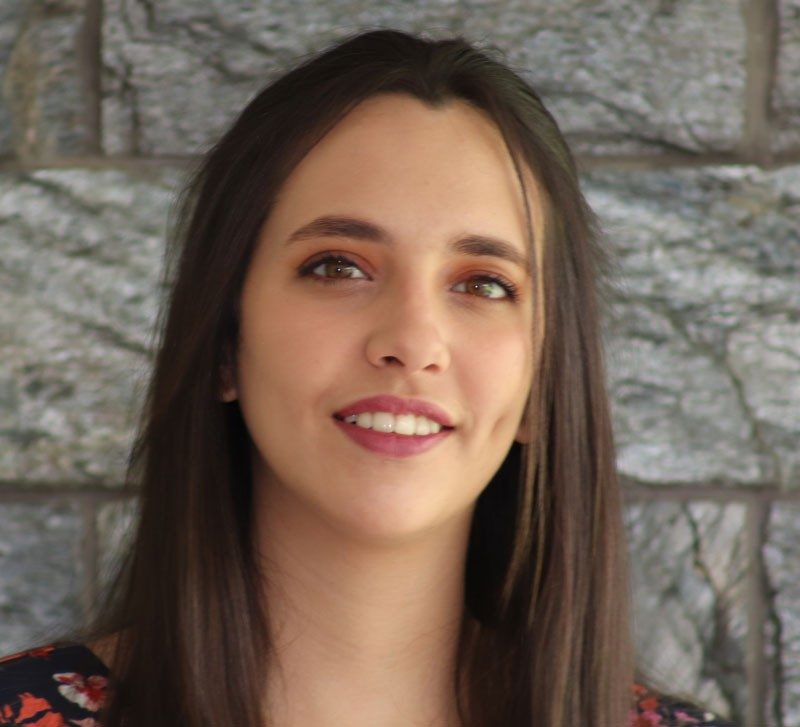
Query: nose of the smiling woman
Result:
<box><xmin>366</xmin><ymin>286</ymin><xmax>450</xmax><ymax>374</ymax></box>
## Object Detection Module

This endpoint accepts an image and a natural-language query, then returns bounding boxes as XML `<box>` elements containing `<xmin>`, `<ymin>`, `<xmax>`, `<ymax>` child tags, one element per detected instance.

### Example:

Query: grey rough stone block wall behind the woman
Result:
<box><xmin>0</xmin><ymin>0</ymin><xmax>800</xmax><ymax>727</ymax></box>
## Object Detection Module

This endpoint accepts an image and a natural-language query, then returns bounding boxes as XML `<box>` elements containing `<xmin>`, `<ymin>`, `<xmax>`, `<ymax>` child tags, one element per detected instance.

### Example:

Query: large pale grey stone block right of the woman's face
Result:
<box><xmin>586</xmin><ymin>167</ymin><xmax>800</xmax><ymax>487</ymax></box>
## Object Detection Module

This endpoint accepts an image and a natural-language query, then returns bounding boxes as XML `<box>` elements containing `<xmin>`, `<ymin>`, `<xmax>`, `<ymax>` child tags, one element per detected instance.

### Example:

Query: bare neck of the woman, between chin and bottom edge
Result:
<box><xmin>255</xmin><ymin>478</ymin><xmax>472</xmax><ymax>727</ymax></box>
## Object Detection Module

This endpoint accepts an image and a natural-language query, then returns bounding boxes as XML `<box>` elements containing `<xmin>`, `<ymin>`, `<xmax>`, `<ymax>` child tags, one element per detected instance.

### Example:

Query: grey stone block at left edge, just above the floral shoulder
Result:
<box><xmin>0</xmin><ymin>500</ymin><xmax>83</xmax><ymax>654</ymax></box>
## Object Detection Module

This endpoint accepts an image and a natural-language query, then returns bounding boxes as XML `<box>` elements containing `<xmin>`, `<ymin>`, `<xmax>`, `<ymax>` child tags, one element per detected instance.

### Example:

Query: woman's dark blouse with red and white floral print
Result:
<box><xmin>0</xmin><ymin>644</ymin><xmax>733</xmax><ymax>727</ymax></box>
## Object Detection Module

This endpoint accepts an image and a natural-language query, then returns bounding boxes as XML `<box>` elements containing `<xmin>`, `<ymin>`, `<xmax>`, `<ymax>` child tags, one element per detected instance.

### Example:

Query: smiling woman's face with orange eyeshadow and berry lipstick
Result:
<box><xmin>227</xmin><ymin>95</ymin><xmax>538</xmax><ymax>541</ymax></box>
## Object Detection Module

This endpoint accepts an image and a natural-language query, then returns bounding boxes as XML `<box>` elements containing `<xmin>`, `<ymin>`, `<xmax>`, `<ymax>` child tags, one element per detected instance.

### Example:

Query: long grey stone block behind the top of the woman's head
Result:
<box><xmin>103</xmin><ymin>0</ymin><xmax>744</xmax><ymax>154</ymax></box>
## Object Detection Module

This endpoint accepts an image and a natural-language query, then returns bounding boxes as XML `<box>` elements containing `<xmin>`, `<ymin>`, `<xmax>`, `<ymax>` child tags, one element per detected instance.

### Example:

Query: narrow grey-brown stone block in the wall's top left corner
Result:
<box><xmin>0</xmin><ymin>0</ymin><xmax>93</xmax><ymax>159</ymax></box>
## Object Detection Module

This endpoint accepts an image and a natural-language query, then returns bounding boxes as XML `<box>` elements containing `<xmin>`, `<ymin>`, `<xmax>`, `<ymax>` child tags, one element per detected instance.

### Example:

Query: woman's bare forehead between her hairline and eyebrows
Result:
<box><xmin>268</xmin><ymin>94</ymin><xmax>538</xmax><ymax>250</ymax></box>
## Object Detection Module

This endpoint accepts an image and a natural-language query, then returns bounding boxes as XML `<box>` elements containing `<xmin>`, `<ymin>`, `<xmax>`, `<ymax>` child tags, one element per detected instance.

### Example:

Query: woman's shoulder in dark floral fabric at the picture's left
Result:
<box><xmin>0</xmin><ymin>644</ymin><xmax>109</xmax><ymax>727</ymax></box>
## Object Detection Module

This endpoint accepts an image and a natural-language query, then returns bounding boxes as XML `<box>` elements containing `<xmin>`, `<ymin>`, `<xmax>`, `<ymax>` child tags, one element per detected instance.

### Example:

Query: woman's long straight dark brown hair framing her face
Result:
<box><xmin>86</xmin><ymin>30</ymin><xmax>632</xmax><ymax>727</ymax></box>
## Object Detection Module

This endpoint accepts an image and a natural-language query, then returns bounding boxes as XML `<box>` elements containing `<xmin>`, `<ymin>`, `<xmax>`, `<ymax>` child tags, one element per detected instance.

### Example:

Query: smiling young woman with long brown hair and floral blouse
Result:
<box><xmin>0</xmin><ymin>31</ymin><xmax>736</xmax><ymax>727</ymax></box>
